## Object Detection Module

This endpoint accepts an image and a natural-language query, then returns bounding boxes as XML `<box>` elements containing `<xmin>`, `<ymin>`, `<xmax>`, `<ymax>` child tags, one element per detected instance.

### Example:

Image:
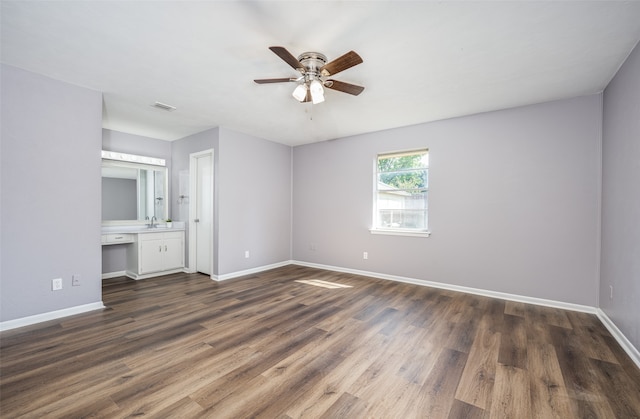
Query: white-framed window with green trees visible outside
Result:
<box><xmin>371</xmin><ymin>150</ymin><xmax>429</xmax><ymax>235</ymax></box>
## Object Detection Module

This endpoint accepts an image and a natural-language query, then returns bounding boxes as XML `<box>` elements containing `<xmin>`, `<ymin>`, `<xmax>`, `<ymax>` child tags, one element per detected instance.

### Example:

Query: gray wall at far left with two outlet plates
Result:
<box><xmin>0</xmin><ymin>65</ymin><xmax>102</xmax><ymax>322</ymax></box>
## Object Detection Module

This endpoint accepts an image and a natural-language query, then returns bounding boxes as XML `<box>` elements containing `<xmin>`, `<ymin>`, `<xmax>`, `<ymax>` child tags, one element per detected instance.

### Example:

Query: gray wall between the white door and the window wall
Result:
<box><xmin>216</xmin><ymin>128</ymin><xmax>291</xmax><ymax>275</ymax></box>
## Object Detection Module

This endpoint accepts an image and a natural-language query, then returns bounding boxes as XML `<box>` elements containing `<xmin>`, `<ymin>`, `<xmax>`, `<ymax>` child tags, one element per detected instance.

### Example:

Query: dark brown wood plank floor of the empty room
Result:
<box><xmin>0</xmin><ymin>266</ymin><xmax>640</xmax><ymax>419</ymax></box>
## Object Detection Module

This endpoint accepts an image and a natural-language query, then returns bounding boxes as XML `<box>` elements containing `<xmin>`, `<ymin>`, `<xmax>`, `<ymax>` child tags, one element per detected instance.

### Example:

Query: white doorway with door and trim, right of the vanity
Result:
<box><xmin>189</xmin><ymin>149</ymin><xmax>214</xmax><ymax>279</ymax></box>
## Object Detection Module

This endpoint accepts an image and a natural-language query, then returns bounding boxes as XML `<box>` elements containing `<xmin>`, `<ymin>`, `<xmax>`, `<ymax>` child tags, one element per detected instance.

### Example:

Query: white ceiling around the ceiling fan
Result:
<box><xmin>1</xmin><ymin>0</ymin><xmax>640</xmax><ymax>145</ymax></box>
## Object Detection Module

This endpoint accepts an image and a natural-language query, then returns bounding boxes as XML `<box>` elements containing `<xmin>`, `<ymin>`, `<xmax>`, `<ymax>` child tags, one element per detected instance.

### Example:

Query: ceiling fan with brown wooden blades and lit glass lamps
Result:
<box><xmin>254</xmin><ymin>47</ymin><xmax>364</xmax><ymax>105</ymax></box>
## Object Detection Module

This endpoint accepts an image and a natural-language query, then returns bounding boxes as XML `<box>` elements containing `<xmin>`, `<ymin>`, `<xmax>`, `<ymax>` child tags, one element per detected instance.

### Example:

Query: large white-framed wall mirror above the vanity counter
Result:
<box><xmin>102</xmin><ymin>154</ymin><xmax>169</xmax><ymax>224</ymax></box>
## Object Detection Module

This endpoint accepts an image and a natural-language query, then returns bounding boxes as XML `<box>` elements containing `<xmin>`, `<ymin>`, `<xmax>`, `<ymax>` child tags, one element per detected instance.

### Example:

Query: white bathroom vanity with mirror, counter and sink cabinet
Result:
<box><xmin>102</xmin><ymin>150</ymin><xmax>185</xmax><ymax>279</ymax></box>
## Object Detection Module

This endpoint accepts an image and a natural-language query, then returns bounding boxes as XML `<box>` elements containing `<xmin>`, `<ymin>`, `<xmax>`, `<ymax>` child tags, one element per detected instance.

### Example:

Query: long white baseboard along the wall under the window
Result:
<box><xmin>291</xmin><ymin>260</ymin><xmax>596</xmax><ymax>314</ymax></box>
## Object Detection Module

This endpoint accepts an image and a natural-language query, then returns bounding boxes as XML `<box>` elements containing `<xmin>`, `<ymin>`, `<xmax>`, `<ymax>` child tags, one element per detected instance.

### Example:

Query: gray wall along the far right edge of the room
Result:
<box><xmin>599</xmin><ymin>41</ymin><xmax>640</xmax><ymax>349</ymax></box>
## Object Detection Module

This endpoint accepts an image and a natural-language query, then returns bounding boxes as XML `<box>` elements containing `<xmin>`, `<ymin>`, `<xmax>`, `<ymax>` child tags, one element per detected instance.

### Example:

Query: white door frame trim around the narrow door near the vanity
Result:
<box><xmin>189</xmin><ymin>148</ymin><xmax>215</xmax><ymax>279</ymax></box>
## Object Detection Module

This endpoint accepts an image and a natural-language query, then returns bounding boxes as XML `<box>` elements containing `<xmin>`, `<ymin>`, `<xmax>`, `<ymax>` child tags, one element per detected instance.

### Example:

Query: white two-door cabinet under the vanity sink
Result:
<box><xmin>127</xmin><ymin>231</ymin><xmax>184</xmax><ymax>279</ymax></box>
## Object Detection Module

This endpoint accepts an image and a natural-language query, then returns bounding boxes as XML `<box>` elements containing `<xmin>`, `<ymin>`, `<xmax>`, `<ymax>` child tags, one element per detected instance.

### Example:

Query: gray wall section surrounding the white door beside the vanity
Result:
<box><xmin>171</xmin><ymin>128</ymin><xmax>220</xmax><ymax>272</ymax></box>
